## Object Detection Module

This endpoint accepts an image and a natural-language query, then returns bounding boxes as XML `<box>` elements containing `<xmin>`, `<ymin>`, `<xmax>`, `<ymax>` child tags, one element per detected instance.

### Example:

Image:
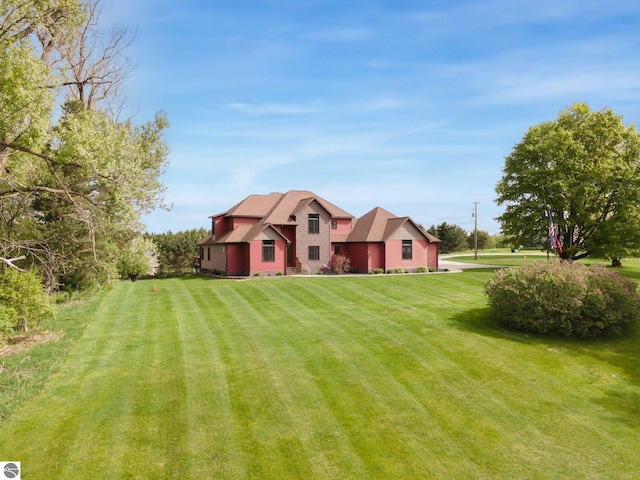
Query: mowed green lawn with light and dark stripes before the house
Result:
<box><xmin>0</xmin><ymin>270</ymin><xmax>640</xmax><ymax>480</ymax></box>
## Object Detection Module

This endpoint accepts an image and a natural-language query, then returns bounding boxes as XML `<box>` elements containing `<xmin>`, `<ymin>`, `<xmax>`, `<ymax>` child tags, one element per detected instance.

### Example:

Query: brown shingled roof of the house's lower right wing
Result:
<box><xmin>347</xmin><ymin>207</ymin><xmax>440</xmax><ymax>243</ymax></box>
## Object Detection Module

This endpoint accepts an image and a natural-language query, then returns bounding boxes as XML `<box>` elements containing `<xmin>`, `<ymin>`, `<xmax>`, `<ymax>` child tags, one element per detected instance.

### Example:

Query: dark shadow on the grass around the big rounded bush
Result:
<box><xmin>450</xmin><ymin>307</ymin><xmax>640</xmax><ymax>428</ymax></box>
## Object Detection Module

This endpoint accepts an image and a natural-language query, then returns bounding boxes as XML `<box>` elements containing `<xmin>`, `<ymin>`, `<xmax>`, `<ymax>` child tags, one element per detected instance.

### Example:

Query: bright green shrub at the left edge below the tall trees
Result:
<box><xmin>0</xmin><ymin>268</ymin><xmax>53</xmax><ymax>337</ymax></box>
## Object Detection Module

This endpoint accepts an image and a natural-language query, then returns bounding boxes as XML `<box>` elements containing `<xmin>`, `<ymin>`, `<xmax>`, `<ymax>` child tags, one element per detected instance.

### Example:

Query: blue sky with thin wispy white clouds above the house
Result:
<box><xmin>103</xmin><ymin>0</ymin><xmax>640</xmax><ymax>233</ymax></box>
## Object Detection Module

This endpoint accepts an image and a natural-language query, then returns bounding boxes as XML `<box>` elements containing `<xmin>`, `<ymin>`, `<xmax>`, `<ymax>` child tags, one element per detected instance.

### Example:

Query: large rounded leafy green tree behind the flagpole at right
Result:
<box><xmin>496</xmin><ymin>103</ymin><xmax>640</xmax><ymax>263</ymax></box>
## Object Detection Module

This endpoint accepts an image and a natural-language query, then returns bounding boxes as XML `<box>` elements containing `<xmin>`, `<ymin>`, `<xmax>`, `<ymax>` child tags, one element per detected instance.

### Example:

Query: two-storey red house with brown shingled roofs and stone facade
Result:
<box><xmin>198</xmin><ymin>190</ymin><xmax>440</xmax><ymax>276</ymax></box>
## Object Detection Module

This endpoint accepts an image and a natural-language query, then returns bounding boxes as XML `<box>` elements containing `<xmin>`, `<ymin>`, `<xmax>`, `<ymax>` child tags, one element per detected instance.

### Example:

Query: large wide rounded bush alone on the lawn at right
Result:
<box><xmin>485</xmin><ymin>262</ymin><xmax>640</xmax><ymax>337</ymax></box>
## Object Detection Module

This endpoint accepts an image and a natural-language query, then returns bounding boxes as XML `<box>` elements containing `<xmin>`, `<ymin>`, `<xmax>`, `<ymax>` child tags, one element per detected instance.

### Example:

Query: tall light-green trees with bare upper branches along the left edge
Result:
<box><xmin>0</xmin><ymin>0</ymin><xmax>168</xmax><ymax>292</ymax></box>
